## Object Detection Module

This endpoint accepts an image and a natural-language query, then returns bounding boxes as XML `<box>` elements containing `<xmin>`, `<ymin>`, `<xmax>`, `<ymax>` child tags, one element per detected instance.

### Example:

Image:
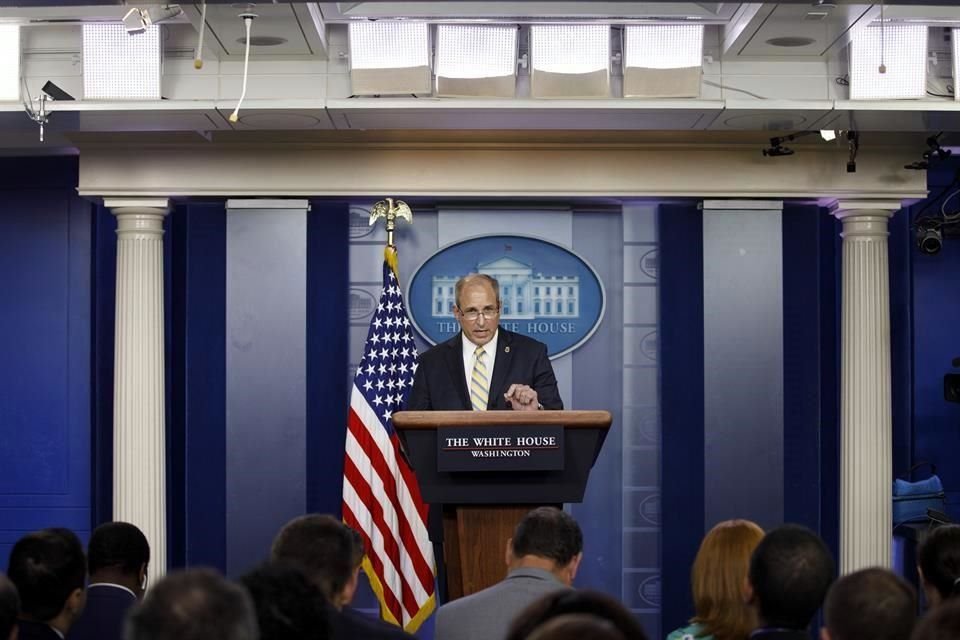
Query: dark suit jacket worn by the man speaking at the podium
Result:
<box><xmin>405</xmin><ymin>327</ymin><xmax>563</xmax><ymax>411</ymax></box>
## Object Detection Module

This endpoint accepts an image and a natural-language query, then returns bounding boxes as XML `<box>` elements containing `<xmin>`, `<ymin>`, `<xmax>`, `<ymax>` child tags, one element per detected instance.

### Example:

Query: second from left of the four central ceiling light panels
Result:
<box><xmin>435</xmin><ymin>24</ymin><xmax>517</xmax><ymax>98</ymax></box>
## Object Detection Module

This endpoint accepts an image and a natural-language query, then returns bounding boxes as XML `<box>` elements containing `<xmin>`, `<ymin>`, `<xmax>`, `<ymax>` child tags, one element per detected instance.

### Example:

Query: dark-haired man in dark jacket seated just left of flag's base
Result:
<box><xmin>270</xmin><ymin>514</ymin><xmax>413</xmax><ymax>640</ymax></box>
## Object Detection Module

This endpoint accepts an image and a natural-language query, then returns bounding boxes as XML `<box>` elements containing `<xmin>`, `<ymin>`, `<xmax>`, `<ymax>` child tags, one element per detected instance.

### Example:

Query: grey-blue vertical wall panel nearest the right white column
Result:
<box><xmin>703</xmin><ymin>210</ymin><xmax>784</xmax><ymax>529</ymax></box>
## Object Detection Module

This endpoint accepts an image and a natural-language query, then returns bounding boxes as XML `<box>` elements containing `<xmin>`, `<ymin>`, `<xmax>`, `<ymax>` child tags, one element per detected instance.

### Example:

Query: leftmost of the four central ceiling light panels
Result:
<box><xmin>350</xmin><ymin>20</ymin><xmax>431</xmax><ymax>95</ymax></box>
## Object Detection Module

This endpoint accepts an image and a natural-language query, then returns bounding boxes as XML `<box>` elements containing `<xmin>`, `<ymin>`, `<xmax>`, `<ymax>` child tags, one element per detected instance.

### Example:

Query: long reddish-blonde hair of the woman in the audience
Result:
<box><xmin>691</xmin><ymin>520</ymin><xmax>763</xmax><ymax>640</ymax></box>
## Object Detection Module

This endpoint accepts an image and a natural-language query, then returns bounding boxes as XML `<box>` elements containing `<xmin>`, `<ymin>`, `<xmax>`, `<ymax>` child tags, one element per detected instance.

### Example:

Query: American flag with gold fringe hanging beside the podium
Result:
<box><xmin>343</xmin><ymin>247</ymin><xmax>436</xmax><ymax>632</ymax></box>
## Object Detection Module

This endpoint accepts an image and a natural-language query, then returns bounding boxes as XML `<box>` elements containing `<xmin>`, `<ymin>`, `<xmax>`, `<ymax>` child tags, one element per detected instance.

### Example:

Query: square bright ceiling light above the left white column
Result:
<box><xmin>83</xmin><ymin>24</ymin><xmax>161</xmax><ymax>100</ymax></box>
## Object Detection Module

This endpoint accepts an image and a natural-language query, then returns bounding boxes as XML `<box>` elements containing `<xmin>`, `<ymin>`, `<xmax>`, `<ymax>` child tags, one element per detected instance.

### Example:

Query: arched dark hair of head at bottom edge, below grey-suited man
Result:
<box><xmin>506</xmin><ymin>589</ymin><xmax>647</xmax><ymax>640</ymax></box>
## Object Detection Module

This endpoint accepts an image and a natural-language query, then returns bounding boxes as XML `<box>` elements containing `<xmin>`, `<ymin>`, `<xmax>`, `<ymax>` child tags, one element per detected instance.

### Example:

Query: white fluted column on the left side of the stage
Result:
<box><xmin>104</xmin><ymin>198</ymin><xmax>168</xmax><ymax>582</ymax></box>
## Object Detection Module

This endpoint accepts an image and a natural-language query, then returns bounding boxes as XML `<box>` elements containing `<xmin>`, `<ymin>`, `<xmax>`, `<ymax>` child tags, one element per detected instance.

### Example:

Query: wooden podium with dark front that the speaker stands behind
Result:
<box><xmin>393</xmin><ymin>411</ymin><xmax>612</xmax><ymax>600</ymax></box>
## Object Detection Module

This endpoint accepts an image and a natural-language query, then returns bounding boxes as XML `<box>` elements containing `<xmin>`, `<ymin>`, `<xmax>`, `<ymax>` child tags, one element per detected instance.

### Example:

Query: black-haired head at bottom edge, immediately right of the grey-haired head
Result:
<box><xmin>240</xmin><ymin>563</ymin><xmax>330</xmax><ymax>640</ymax></box>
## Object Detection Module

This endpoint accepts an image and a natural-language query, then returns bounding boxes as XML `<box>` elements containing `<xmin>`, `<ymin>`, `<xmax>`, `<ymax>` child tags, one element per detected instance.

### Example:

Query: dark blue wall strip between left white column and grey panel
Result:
<box><xmin>173</xmin><ymin>203</ymin><xmax>227</xmax><ymax>571</ymax></box>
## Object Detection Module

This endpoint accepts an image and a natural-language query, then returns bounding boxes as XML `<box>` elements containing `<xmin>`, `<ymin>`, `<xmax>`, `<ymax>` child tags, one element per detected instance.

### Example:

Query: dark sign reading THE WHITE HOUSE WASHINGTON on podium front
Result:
<box><xmin>437</xmin><ymin>425</ymin><xmax>563</xmax><ymax>472</ymax></box>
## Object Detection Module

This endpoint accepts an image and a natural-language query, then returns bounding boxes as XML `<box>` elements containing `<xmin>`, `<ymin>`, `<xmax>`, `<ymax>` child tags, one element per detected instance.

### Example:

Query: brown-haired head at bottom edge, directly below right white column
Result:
<box><xmin>820</xmin><ymin>568</ymin><xmax>917</xmax><ymax>640</ymax></box>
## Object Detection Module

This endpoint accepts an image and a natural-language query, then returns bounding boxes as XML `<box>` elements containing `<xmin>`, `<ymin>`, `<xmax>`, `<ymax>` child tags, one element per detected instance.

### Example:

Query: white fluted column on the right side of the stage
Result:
<box><xmin>834</xmin><ymin>200</ymin><xmax>901</xmax><ymax>574</ymax></box>
